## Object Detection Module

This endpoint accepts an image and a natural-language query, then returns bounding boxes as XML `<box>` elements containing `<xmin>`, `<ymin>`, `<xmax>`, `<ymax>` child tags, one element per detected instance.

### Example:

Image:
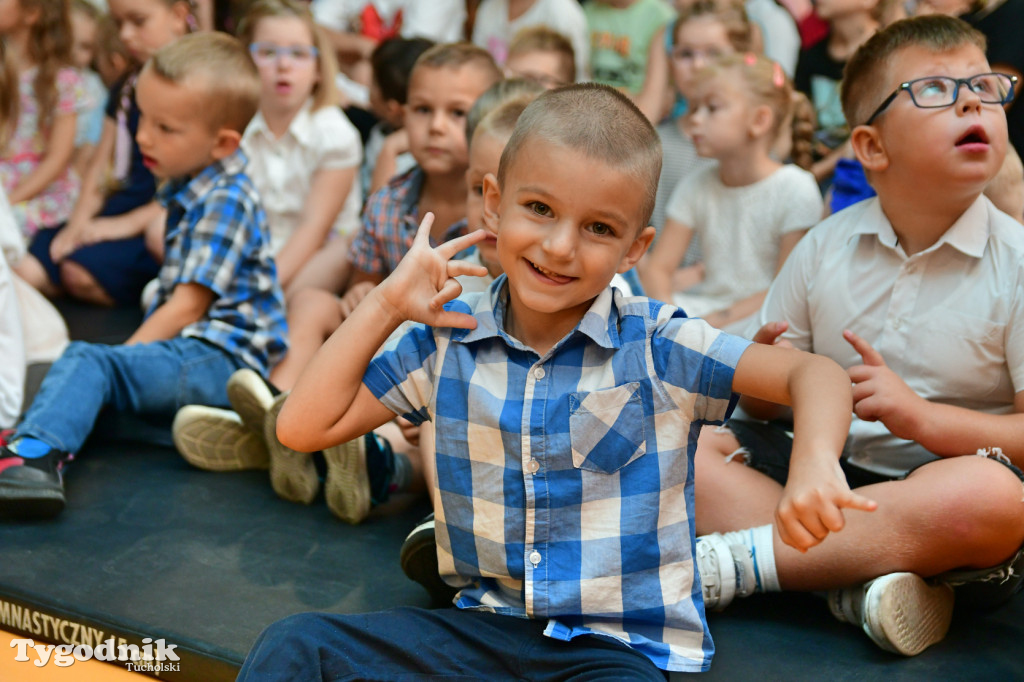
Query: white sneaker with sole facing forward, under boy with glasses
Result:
<box><xmin>828</xmin><ymin>572</ymin><xmax>953</xmax><ymax>656</ymax></box>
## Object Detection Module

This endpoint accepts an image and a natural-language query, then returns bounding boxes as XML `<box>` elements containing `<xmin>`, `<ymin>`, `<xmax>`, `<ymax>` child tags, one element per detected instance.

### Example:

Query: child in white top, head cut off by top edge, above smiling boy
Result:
<box><xmin>472</xmin><ymin>0</ymin><xmax>590</xmax><ymax>85</ymax></box>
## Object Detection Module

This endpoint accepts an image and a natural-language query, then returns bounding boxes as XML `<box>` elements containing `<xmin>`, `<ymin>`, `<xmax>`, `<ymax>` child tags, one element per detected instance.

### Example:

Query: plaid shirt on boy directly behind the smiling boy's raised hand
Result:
<box><xmin>348</xmin><ymin>166</ymin><xmax>466</xmax><ymax>278</ymax></box>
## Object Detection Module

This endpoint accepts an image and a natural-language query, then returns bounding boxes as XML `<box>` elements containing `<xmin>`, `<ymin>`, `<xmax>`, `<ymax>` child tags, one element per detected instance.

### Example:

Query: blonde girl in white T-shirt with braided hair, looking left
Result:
<box><xmin>641</xmin><ymin>52</ymin><xmax>822</xmax><ymax>333</ymax></box>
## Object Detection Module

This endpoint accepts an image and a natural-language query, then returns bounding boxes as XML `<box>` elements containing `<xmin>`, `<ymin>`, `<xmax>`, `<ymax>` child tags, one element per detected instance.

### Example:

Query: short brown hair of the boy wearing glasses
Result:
<box><xmin>840</xmin><ymin>14</ymin><xmax>986</xmax><ymax>127</ymax></box>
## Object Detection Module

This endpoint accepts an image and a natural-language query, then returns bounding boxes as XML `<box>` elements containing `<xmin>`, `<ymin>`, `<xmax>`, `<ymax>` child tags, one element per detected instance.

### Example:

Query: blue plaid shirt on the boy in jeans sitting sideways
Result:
<box><xmin>146</xmin><ymin>152</ymin><xmax>288</xmax><ymax>377</ymax></box>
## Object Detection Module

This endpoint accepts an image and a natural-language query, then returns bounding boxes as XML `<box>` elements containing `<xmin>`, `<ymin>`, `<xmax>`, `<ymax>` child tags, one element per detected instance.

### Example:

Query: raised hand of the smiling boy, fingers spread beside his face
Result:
<box><xmin>375</xmin><ymin>213</ymin><xmax>487</xmax><ymax>329</ymax></box>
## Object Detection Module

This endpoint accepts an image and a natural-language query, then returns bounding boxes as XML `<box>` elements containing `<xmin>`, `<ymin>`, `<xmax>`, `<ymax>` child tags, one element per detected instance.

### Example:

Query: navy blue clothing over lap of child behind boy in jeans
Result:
<box><xmin>29</xmin><ymin>224</ymin><xmax>160</xmax><ymax>305</ymax></box>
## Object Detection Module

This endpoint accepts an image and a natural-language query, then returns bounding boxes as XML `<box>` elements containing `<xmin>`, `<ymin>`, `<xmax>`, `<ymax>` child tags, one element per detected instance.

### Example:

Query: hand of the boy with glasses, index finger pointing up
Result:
<box><xmin>843</xmin><ymin>330</ymin><xmax>927</xmax><ymax>440</ymax></box>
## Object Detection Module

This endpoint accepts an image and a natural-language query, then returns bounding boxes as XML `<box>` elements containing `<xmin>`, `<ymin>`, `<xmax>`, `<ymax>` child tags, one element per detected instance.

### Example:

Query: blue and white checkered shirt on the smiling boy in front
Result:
<box><xmin>364</xmin><ymin>275</ymin><xmax>749</xmax><ymax>672</ymax></box>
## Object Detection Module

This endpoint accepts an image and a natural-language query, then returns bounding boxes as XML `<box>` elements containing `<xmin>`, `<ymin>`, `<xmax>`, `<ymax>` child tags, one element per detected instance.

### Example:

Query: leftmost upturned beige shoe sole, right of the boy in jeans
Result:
<box><xmin>171</xmin><ymin>404</ymin><xmax>269</xmax><ymax>471</ymax></box>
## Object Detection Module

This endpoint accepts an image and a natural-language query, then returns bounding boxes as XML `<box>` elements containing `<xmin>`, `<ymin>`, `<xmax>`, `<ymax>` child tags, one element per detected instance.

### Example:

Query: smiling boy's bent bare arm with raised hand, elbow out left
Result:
<box><xmin>278</xmin><ymin>213</ymin><xmax>486</xmax><ymax>452</ymax></box>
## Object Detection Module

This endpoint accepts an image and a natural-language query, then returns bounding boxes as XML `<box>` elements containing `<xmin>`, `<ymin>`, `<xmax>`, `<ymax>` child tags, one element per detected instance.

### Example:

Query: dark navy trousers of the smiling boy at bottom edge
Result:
<box><xmin>238</xmin><ymin>607</ymin><xmax>668</xmax><ymax>682</ymax></box>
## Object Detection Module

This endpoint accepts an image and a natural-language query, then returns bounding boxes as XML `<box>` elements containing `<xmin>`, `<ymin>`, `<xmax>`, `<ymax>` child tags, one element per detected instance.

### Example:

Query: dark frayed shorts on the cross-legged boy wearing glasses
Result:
<box><xmin>725</xmin><ymin>419</ymin><xmax>1024</xmax><ymax>608</ymax></box>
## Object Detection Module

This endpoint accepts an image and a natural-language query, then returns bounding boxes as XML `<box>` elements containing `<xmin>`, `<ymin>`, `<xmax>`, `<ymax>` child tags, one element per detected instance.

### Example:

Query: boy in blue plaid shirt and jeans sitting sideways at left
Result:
<box><xmin>0</xmin><ymin>33</ymin><xmax>287</xmax><ymax>518</ymax></box>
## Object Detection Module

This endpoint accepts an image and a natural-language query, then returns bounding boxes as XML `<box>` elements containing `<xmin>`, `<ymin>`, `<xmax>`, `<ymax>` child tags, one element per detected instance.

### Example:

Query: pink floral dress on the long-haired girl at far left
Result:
<box><xmin>0</xmin><ymin>67</ymin><xmax>90</xmax><ymax>240</ymax></box>
